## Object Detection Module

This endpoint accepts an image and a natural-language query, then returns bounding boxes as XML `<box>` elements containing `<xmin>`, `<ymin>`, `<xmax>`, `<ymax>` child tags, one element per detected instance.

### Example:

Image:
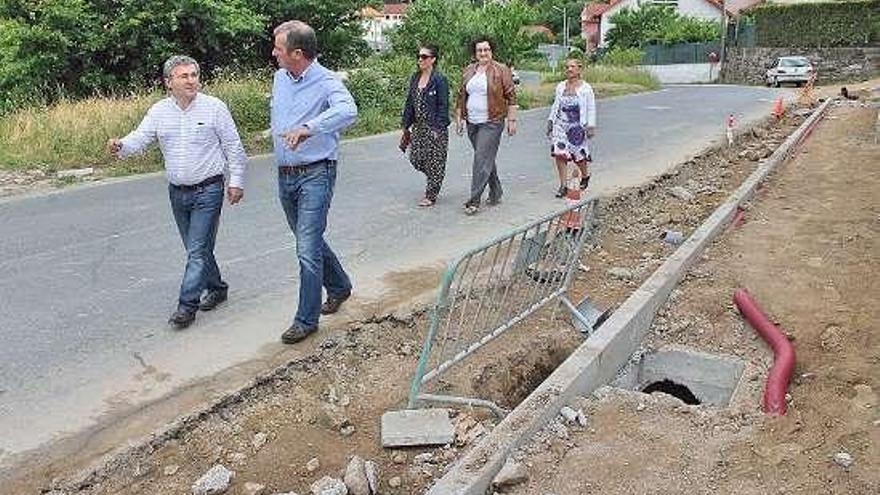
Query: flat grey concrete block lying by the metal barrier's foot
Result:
<box><xmin>382</xmin><ymin>409</ymin><xmax>455</xmax><ymax>447</ymax></box>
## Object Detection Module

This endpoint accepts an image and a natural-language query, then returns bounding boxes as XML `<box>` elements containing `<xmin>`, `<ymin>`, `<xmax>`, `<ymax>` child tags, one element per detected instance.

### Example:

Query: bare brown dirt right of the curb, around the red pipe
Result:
<box><xmin>505</xmin><ymin>104</ymin><xmax>880</xmax><ymax>495</ymax></box>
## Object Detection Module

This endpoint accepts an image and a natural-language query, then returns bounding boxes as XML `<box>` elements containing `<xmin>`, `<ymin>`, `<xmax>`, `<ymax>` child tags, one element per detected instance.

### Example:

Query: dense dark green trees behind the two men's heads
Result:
<box><xmin>0</xmin><ymin>0</ymin><xmax>370</xmax><ymax>115</ymax></box>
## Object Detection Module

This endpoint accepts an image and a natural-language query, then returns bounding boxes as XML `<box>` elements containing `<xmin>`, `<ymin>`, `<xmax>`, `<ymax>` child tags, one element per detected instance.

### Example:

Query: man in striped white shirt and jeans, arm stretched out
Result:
<box><xmin>107</xmin><ymin>55</ymin><xmax>247</xmax><ymax>328</ymax></box>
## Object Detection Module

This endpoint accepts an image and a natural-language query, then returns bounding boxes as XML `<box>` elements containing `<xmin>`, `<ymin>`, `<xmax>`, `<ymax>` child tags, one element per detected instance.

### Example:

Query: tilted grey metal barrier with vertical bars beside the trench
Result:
<box><xmin>408</xmin><ymin>199</ymin><xmax>596</xmax><ymax>413</ymax></box>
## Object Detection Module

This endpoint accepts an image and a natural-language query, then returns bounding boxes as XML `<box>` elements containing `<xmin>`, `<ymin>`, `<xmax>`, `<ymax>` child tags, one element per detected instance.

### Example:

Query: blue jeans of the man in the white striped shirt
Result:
<box><xmin>168</xmin><ymin>181</ymin><xmax>228</xmax><ymax>312</ymax></box>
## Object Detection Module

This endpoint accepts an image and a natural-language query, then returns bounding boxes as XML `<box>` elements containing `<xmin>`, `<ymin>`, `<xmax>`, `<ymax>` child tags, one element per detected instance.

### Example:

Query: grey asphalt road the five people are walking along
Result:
<box><xmin>0</xmin><ymin>86</ymin><xmax>784</xmax><ymax>467</ymax></box>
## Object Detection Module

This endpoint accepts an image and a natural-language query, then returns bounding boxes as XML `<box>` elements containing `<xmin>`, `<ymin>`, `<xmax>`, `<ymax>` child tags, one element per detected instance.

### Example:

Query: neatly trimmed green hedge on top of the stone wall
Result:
<box><xmin>750</xmin><ymin>0</ymin><xmax>880</xmax><ymax>48</ymax></box>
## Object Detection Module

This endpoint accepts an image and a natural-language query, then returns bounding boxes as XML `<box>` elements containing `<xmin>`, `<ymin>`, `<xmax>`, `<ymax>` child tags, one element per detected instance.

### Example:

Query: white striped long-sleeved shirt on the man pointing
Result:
<box><xmin>120</xmin><ymin>93</ymin><xmax>247</xmax><ymax>187</ymax></box>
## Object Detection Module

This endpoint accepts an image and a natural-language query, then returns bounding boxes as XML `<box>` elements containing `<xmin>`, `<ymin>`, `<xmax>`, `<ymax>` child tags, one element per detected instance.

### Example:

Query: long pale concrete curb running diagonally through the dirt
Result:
<box><xmin>427</xmin><ymin>100</ymin><xmax>831</xmax><ymax>495</ymax></box>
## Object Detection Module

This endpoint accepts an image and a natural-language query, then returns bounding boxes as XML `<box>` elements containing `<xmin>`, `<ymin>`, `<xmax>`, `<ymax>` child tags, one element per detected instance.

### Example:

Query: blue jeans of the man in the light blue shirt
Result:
<box><xmin>278</xmin><ymin>163</ymin><xmax>351</xmax><ymax>328</ymax></box>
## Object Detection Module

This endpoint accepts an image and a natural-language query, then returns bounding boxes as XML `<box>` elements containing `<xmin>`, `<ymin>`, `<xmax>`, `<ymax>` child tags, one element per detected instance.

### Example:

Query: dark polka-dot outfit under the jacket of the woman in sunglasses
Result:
<box><xmin>409</xmin><ymin>87</ymin><xmax>449</xmax><ymax>201</ymax></box>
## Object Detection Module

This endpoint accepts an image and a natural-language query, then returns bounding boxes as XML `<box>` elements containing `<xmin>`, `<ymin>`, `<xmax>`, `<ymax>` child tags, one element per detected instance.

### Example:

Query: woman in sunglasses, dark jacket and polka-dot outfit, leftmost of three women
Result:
<box><xmin>400</xmin><ymin>45</ymin><xmax>449</xmax><ymax>207</ymax></box>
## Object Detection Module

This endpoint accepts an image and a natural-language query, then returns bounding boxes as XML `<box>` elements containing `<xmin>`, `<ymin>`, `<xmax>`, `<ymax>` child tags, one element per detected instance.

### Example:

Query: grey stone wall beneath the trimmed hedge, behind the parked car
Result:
<box><xmin>721</xmin><ymin>47</ymin><xmax>880</xmax><ymax>84</ymax></box>
